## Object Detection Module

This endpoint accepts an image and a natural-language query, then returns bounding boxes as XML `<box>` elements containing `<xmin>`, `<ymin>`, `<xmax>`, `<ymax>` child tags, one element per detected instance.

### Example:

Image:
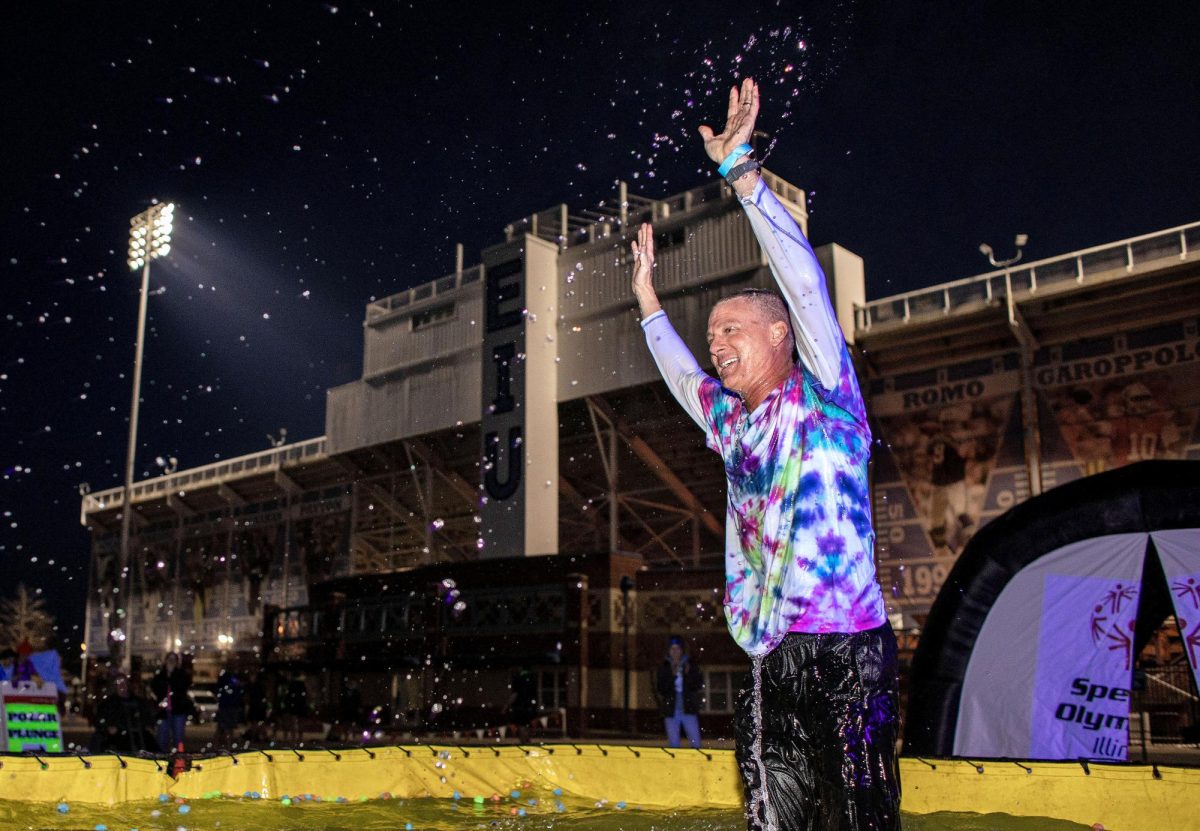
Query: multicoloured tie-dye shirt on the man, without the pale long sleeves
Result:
<box><xmin>698</xmin><ymin>355</ymin><xmax>886</xmax><ymax>654</ymax></box>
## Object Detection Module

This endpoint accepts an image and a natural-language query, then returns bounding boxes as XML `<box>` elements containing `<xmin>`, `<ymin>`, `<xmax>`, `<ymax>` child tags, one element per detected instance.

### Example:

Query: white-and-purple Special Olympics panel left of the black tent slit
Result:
<box><xmin>954</xmin><ymin>533</ymin><xmax>1148</xmax><ymax>760</ymax></box>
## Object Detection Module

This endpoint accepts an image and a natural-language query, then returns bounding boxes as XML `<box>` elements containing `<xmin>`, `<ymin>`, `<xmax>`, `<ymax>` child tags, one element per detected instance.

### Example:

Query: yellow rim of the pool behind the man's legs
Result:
<box><xmin>0</xmin><ymin>745</ymin><xmax>1200</xmax><ymax>831</ymax></box>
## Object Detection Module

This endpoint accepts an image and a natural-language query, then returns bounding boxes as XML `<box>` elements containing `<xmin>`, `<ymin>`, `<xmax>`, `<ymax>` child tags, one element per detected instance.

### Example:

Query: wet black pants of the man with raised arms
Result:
<box><xmin>736</xmin><ymin>623</ymin><xmax>900</xmax><ymax>831</ymax></box>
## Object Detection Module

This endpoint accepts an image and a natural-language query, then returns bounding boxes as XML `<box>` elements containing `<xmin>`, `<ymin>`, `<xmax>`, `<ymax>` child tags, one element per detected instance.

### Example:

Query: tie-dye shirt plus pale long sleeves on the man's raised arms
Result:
<box><xmin>642</xmin><ymin>183</ymin><xmax>887</xmax><ymax>656</ymax></box>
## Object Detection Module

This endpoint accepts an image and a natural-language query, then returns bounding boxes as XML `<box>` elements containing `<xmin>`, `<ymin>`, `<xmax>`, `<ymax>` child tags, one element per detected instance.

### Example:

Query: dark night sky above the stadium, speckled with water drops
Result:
<box><xmin>0</xmin><ymin>0</ymin><xmax>1200</xmax><ymax>644</ymax></box>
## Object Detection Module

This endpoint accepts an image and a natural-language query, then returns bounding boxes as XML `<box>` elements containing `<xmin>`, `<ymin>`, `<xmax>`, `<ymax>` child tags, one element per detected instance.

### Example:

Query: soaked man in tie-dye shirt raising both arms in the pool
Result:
<box><xmin>632</xmin><ymin>78</ymin><xmax>900</xmax><ymax>831</ymax></box>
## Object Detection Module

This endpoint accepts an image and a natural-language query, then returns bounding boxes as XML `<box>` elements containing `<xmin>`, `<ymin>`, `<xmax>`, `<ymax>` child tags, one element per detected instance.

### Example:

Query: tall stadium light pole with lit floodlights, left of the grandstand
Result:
<box><xmin>108</xmin><ymin>203</ymin><xmax>175</xmax><ymax>672</ymax></box>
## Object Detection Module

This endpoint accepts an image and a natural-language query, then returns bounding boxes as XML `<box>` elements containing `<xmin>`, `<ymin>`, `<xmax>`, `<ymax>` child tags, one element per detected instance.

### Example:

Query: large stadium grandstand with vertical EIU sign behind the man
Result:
<box><xmin>80</xmin><ymin>174</ymin><xmax>1200</xmax><ymax>743</ymax></box>
